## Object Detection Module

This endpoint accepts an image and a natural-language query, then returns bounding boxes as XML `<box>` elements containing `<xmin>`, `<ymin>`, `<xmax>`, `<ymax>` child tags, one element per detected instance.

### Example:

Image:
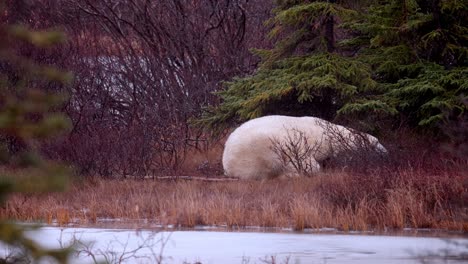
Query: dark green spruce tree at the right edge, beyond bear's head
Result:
<box><xmin>340</xmin><ymin>0</ymin><xmax>468</xmax><ymax>130</ymax></box>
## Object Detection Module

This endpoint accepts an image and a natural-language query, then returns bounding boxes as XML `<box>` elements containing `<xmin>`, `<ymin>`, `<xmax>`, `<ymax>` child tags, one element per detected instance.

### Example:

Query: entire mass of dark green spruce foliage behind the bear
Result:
<box><xmin>200</xmin><ymin>0</ymin><xmax>468</xmax><ymax>136</ymax></box>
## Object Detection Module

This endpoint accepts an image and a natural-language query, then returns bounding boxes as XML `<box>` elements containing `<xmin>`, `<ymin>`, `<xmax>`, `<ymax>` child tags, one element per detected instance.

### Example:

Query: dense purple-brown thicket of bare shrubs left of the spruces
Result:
<box><xmin>0</xmin><ymin>0</ymin><xmax>273</xmax><ymax>177</ymax></box>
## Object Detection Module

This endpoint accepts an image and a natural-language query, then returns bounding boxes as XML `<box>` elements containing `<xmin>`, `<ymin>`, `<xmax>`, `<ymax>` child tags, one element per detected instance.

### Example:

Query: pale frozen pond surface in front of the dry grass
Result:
<box><xmin>1</xmin><ymin>227</ymin><xmax>468</xmax><ymax>264</ymax></box>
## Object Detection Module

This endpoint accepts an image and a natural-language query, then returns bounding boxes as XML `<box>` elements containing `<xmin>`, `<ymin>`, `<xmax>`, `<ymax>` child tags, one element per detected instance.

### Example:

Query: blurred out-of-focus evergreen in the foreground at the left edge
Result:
<box><xmin>0</xmin><ymin>7</ymin><xmax>70</xmax><ymax>263</ymax></box>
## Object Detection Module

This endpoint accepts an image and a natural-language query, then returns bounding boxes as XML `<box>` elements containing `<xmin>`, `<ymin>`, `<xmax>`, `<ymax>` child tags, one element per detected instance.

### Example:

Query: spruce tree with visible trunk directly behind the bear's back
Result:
<box><xmin>199</xmin><ymin>0</ymin><xmax>376</xmax><ymax>132</ymax></box>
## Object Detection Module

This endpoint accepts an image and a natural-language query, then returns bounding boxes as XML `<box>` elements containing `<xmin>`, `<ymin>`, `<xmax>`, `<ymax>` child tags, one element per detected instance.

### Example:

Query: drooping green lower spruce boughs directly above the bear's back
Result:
<box><xmin>204</xmin><ymin>53</ymin><xmax>375</xmax><ymax>131</ymax></box>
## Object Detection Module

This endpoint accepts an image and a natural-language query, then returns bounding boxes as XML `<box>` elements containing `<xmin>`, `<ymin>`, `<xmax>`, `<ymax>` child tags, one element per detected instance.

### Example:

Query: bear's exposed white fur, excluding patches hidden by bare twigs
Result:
<box><xmin>223</xmin><ymin>115</ymin><xmax>386</xmax><ymax>179</ymax></box>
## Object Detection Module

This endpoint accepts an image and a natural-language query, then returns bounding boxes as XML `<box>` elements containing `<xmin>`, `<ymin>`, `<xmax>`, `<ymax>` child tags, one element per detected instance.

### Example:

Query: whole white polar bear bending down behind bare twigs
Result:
<box><xmin>222</xmin><ymin>115</ymin><xmax>386</xmax><ymax>180</ymax></box>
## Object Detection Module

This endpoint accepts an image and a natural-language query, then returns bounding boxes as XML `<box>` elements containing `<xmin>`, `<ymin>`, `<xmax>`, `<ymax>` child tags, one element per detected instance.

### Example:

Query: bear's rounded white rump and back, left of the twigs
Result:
<box><xmin>223</xmin><ymin>115</ymin><xmax>323</xmax><ymax>179</ymax></box>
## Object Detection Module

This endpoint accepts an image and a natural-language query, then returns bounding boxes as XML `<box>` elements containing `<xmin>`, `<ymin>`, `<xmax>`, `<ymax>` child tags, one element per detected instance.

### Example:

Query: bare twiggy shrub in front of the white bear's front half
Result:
<box><xmin>271</xmin><ymin>121</ymin><xmax>387</xmax><ymax>176</ymax></box>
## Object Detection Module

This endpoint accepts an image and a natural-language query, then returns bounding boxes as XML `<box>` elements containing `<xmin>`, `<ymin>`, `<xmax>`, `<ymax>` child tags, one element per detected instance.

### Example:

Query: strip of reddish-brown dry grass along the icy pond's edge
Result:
<box><xmin>0</xmin><ymin>166</ymin><xmax>468</xmax><ymax>232</ymax></box>
